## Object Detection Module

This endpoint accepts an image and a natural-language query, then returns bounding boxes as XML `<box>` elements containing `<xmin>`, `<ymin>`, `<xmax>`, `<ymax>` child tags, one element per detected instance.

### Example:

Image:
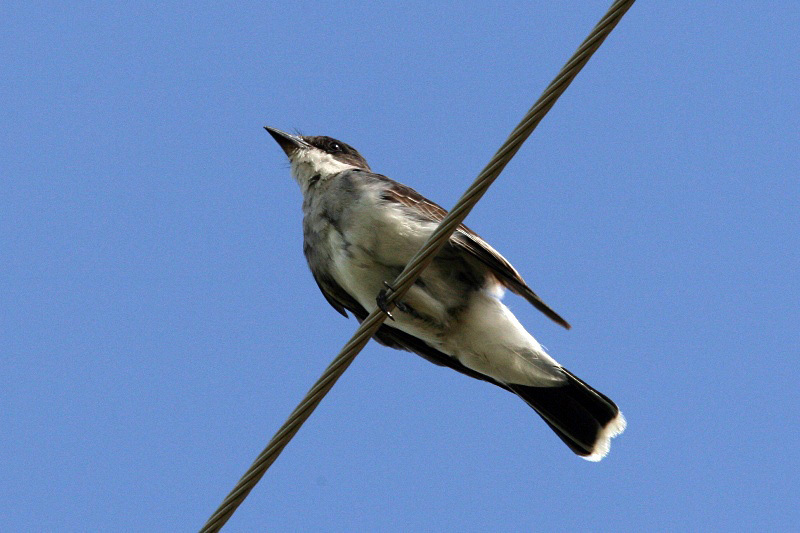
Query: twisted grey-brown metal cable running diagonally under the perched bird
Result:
<box><xmin>200</xmin><ymin>0</ymin><xmax>634</xmax><ymax>533</ymax></box>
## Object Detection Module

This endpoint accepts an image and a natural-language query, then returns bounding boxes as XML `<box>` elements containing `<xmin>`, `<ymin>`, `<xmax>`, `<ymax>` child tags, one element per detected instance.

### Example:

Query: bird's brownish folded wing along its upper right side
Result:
<box><xmin>375</xmin><ymin>174</ymin><xmax>570</xmax><ymax>329</ymax></box>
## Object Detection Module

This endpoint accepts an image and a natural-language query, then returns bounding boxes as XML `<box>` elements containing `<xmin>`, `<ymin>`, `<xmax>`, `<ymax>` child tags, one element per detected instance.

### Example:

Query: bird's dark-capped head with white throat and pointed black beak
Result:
<box><xmin>264</xmin><ymin>127</ymin><xmax>370</xmax><ymax>192</ymax></box>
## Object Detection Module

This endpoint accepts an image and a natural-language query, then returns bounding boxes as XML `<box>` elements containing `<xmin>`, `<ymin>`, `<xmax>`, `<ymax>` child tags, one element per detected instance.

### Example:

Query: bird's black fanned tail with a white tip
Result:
<box><xmin>506</xmin><ymin>368</ymin><xmax>625</xmax><ymax>461</ymax></box>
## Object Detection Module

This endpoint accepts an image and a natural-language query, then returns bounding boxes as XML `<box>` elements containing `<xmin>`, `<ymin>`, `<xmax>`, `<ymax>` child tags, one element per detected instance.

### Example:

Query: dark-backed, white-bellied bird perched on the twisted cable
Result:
<box><xmin>265</xmin><ymin>126</ymin><xmax>626</xmax><ymax>461</ymax></box>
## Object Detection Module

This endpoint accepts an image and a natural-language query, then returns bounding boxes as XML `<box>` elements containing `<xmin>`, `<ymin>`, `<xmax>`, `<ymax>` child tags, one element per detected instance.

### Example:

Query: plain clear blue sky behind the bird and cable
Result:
<box><xmin>0</xmin><ymin>1</ymin><xmax>800</xmax><ymax>531</ymax></box>
